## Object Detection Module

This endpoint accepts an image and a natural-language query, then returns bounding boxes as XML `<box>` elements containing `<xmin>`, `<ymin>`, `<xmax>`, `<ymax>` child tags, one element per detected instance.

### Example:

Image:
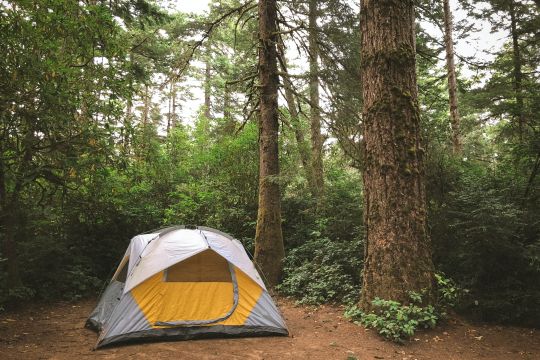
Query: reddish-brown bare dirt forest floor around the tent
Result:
<box><xmin>0</xmin><ymin>299</ymin><xmax>540</xmax><ymax>360</ymax></box>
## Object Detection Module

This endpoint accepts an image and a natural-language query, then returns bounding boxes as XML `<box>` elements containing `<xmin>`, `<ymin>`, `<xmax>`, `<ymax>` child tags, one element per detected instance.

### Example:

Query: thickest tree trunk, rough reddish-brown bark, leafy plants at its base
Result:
<box><xmin>360</xmin><ymin>0</ymin><xmax>434</xmax><ymax>311</ymax></box>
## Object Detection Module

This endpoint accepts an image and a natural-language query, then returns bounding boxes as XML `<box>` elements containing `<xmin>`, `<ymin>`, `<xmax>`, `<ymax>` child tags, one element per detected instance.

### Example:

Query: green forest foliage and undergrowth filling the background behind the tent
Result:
<box><xmin>0</xmin><ymin>0</ymin><xmax>540</xmax><ymax>334</ymax></box>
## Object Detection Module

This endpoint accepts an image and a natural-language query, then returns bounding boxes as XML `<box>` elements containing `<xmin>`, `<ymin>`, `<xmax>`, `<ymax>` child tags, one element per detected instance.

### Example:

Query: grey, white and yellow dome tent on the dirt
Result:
<box><xmin>86</xmin><ymin>226</ymin><xmax>288</xmax><ymax>348</ymax></box>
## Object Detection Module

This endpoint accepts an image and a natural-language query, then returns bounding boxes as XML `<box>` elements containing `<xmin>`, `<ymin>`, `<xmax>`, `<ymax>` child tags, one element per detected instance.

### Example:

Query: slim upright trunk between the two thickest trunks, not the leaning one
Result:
<box><xmin>309</xmin><ymin>0</ymin><xmax>324</xmax><ymax>198</ymax></box>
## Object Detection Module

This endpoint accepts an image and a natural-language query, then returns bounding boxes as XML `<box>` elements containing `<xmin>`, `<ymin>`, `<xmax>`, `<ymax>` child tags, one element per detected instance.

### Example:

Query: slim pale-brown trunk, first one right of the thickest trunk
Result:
<box><xmin>443</xmin><ymin>0</ymin><xmax>461</xmax><ymax>154</ymax></box>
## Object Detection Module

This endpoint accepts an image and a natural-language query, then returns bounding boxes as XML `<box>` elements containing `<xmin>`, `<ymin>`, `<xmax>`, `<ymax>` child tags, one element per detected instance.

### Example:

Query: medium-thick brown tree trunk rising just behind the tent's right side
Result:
<box><xmin>255</xmin><ymin>0</ymin><xmax>284</xmax><ymax>287</ymax></box>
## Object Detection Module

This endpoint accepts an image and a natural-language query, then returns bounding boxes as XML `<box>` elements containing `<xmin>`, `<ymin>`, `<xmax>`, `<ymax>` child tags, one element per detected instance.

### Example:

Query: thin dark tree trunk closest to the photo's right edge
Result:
<box><xmin>509</xmin><ymin>1</ymin><xmax>525</xmax><ymax>140</ymax></box>
